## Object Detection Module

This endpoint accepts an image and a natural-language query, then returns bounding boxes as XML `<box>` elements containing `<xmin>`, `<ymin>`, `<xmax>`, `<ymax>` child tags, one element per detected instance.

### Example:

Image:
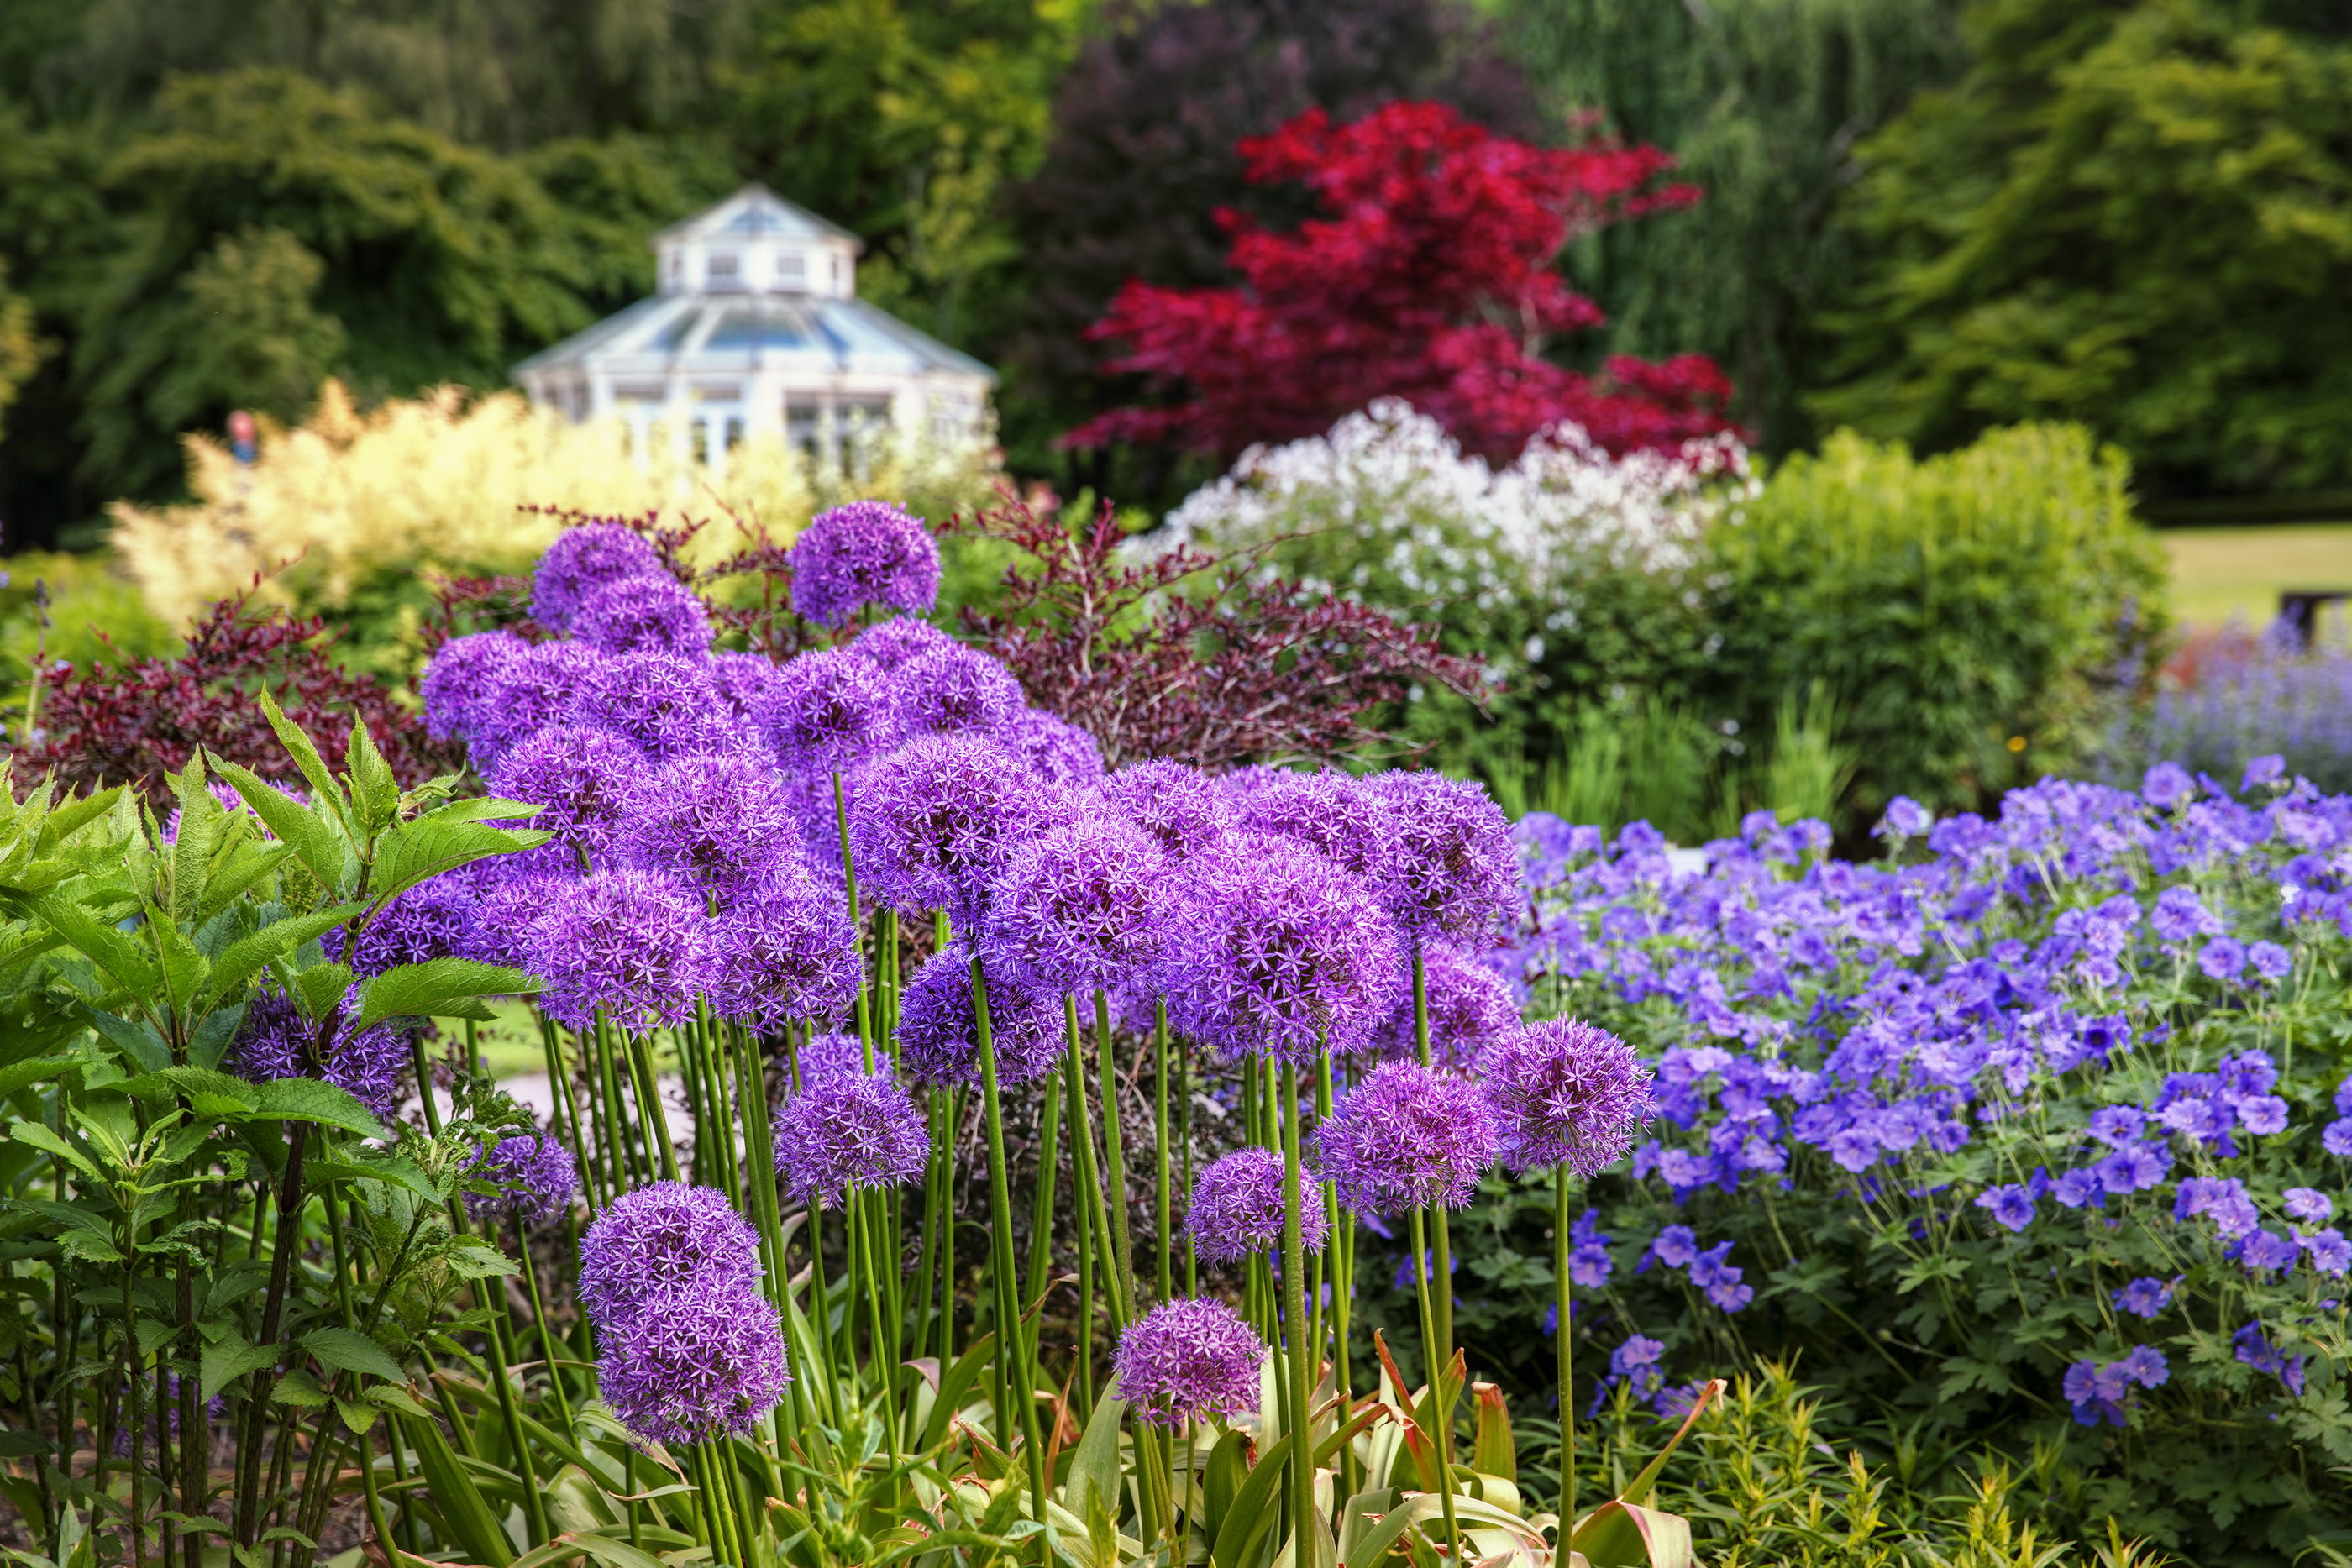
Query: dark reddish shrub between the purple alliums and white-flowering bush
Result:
<box><xmin>946</xmin><ymin>491</ymin><xmax>1487</xmax><ymax>771</ymax></box>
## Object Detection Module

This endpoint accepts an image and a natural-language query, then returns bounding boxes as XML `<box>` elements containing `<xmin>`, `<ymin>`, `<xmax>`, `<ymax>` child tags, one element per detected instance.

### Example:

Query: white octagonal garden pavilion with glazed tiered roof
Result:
<box><xmin>512</xmin><ymin>186</ymin><xmax>997</xmax><ymax>475</ymax></box>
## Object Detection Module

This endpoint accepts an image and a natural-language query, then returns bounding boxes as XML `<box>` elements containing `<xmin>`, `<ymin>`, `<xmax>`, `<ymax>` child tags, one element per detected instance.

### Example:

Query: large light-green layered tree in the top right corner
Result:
<box><xmin>1814</xmin><ymin>0</ymin><xmax>2352</xmax><ymax>489</ymax></box>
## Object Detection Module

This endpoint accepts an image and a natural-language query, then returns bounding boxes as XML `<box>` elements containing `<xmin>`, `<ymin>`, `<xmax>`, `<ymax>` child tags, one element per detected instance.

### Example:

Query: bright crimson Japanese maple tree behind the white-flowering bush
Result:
<box><xmin>1061</xmin><ymin>103</ymin><xmax>1731</xmax><ymax>461</ymax></box>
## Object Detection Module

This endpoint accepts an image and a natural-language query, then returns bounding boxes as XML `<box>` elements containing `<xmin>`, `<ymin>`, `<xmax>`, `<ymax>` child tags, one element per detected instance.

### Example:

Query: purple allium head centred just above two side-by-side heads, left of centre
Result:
<box><xmin>617</xmin><ymin>757</ymin><xmax>800</xmax><ymax>898</ymax></box>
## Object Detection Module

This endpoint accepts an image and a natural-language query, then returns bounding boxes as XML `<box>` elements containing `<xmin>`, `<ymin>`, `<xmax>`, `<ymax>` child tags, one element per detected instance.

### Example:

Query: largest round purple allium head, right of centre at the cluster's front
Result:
<box><xmin>1167</xmin><ymin>836</ymin><xmax>1404</xmax><ymax>1062</ymax></box>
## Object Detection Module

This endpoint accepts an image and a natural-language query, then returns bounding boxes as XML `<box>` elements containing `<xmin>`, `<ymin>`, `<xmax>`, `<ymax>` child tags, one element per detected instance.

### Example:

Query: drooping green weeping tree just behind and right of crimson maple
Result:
<box><xmin>1500</xmin><ymin>0</ymin><xmax>1964</xmax><ymax>451</ymax></box>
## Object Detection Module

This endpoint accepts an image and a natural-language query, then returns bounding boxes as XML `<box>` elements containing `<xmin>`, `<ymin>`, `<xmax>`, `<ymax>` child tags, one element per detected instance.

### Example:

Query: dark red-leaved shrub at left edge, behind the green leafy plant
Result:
<box><xmin>14</xmin><ymin>595</ymin><xmax>461</xmax><ymax>809</ymax></box>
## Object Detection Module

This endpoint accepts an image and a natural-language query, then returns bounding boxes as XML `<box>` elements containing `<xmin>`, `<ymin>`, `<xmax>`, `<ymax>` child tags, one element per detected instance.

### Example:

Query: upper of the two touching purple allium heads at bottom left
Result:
<box><xmin>579</xmin><ymin>1183</ymin><xmax>762</xmax><ymax>1333</ymax></box>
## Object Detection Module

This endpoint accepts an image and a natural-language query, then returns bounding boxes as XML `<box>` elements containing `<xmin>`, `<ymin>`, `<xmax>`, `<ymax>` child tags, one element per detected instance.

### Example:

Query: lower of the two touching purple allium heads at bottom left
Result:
<box><xmin>597</xmin><ymin>1283</ymin><xmax>793</xmax><ymax>1444</ymax></box>
